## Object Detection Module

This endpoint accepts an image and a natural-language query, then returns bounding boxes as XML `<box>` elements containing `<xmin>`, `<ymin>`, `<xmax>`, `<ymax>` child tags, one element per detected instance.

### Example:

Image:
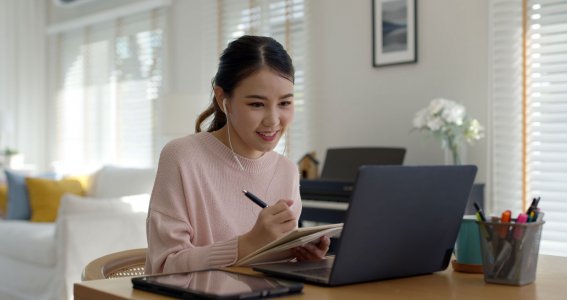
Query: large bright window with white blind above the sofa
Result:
<box><xmin>54</xmin><ymin>9</ymin><xmax>165</xmax><ymax>170</ymax></box>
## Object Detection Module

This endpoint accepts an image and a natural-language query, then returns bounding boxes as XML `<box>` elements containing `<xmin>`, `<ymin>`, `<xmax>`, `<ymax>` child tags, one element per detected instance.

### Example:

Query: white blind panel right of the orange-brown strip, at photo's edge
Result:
<box><xmin>526</xmin><ymin>0</ymin><xmax>567</xmax><ymax>256</ymax></box>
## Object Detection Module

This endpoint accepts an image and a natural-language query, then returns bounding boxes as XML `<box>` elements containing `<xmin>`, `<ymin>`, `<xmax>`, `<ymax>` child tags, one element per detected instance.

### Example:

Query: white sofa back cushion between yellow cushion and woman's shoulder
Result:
<box><xmin>91</xmin><ymin>166</ymin><xmax>156</xmax><ymax>198</ymax></box>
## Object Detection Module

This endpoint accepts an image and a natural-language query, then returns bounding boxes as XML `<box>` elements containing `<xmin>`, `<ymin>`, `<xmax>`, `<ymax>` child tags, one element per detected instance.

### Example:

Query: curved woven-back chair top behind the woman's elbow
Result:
<box><xmin>82</xmin><ymin>248</ymin><xmax>146</xmax><ymax>281</ymax></box>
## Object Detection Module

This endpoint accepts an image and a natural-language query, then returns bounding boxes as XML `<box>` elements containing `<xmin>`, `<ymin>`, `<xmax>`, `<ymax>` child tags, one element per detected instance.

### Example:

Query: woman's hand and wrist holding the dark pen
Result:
<box><xmin>238</xmin><ymin>200</ymin><xmax>297</xmax><ymax>258</ymax></box>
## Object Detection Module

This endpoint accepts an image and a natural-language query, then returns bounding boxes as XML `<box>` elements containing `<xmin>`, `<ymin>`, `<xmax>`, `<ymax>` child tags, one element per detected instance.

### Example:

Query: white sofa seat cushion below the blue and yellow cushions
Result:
<box><xmin>0</xmin><ymin>220</ymin><xmax>55</xmax><ymax>266</ymax></box>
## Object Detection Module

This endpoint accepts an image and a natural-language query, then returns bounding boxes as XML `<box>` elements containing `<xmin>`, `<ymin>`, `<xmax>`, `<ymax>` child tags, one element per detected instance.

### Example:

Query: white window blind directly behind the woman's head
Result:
<box><xmin>217</xmin><ymin>0</ymin><xmax>309</xmax><ymax>161</ymax></box>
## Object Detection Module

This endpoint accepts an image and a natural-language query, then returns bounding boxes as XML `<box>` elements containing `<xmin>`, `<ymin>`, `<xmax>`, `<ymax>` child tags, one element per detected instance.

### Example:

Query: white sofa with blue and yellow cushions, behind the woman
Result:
<box><xmin>0</xmin><ymin>166</ymin><xmax>155</xmax><ymax>300</ymax></box>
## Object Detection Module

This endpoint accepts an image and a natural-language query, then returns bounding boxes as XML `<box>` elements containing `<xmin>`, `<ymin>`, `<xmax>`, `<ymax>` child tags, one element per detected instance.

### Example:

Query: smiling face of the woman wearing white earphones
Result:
<box><xmin>222</xmin><ymin>68</ymin><xmax>294</xmax><ymax>158</ymax></box>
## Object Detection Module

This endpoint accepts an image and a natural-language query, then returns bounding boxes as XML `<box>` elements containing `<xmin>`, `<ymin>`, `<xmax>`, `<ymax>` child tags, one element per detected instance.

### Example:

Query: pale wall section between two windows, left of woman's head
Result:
<box><xmin>162</xmin><ymin>0</ymin><xmax>218</xmax><ymax>140</ymax></box>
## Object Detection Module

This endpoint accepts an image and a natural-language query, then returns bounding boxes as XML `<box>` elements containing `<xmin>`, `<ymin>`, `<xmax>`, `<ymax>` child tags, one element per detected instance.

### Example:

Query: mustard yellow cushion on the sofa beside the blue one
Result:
<box><xmin>26</xmin><ymin>178</ymin><xmax>85</xmax><ymax>222</ymax></box>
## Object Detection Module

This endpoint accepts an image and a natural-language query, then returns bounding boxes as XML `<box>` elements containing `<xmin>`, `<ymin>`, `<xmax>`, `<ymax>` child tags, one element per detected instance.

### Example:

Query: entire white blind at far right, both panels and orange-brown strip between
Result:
<box><xmin>491</xmin><ymin>0</ymin><xmax>567</xmax><ymax>256</ymax></box>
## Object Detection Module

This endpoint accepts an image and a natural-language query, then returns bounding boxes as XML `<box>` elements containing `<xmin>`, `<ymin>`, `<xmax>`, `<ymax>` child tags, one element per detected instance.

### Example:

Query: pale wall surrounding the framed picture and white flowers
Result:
<box><xmin>310</xmin><ymin>0</ymin><xmax>488</xmax><ymax>182</ymax></box>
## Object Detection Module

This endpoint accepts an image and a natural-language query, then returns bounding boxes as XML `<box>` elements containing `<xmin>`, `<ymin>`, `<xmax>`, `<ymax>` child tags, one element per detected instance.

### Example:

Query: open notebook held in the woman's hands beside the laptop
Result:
<box><xmin>235</xmin><ymin>223</ymin><xmax>343</xmax><ymax>266</ymax></box>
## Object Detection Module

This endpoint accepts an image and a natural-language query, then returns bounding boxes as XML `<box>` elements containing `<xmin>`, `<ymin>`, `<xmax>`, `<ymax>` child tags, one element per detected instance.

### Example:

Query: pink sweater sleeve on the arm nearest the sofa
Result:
<box><xmin>145</xmin><ymin>145</ymin><xmax>238</xmax><ymax>274</ymax></box>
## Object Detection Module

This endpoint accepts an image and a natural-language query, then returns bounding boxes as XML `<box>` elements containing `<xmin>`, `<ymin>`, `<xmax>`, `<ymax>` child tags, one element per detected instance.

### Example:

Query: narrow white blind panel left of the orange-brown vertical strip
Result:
<box><xmin>488</xmin><ymin>0</ymin><xmax>523</xmax><ymax>220</ymax></box>
